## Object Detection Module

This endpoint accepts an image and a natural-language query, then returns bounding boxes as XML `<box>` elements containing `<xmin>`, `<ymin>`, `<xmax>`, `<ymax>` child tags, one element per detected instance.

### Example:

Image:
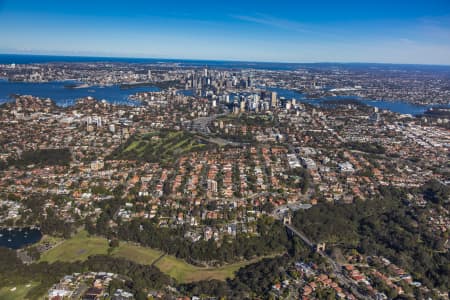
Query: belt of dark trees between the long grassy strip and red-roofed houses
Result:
<box><xmin>86</xmin><ymin>214</ymin><xmax>290</xmax><ymax>264</ymax></box>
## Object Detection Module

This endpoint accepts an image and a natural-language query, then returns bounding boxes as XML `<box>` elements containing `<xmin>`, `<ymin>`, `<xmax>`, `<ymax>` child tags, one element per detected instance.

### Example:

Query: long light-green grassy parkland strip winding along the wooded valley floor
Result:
<box><xmin>38</xmin><ymin>231</ymin><xmax>268</xmax><ymax>282</ymax></box>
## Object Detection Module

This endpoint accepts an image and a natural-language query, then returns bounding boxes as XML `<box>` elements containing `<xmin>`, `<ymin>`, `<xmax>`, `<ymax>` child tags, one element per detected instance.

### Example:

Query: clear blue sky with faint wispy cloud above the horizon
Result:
<box><xmin>0</xmin><ymin>0</ymin><xmax>450</xmax><ymax>65</ymax></box>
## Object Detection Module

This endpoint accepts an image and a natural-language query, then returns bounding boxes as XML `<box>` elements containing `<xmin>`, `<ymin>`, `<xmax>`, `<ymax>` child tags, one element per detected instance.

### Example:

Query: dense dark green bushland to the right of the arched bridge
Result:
<box><xmin>293</xmin><ymin>186</ymin><xmax>450</xmax><ymax>290</ymax></box>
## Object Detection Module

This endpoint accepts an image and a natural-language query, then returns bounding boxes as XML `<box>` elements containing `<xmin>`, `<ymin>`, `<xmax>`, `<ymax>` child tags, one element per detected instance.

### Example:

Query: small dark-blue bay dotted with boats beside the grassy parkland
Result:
<box><xmin>0</xmin><ymin>228</ymin><xmax>42</xmax><ymax>249</ymax></box>
